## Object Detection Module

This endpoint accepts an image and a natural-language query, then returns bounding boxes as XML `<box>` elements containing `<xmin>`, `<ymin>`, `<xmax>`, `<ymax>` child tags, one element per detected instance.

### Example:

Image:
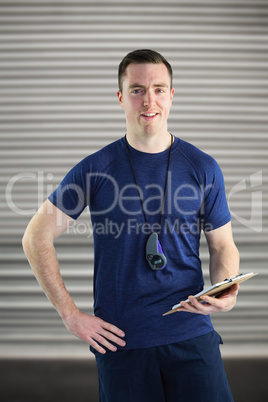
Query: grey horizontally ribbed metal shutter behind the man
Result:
<box><xmin>0</xmin><ymin>0</ymin><xmax>268</xmax><ymax>357</ymax></box>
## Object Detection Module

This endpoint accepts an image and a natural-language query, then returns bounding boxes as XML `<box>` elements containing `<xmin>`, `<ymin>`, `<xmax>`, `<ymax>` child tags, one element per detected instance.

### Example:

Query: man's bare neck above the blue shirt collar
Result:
<box><xmin>127</xmin><ymin>131</ymin><xmax>171</xmax><ymax>154</ymax></box>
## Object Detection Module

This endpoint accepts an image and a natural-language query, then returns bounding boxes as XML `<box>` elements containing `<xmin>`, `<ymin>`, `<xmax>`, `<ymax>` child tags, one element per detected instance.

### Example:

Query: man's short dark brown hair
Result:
<box><xmin>118</xmin><ymin>49</ymin><xmax>173</xmax><ymax>92</ymax></box>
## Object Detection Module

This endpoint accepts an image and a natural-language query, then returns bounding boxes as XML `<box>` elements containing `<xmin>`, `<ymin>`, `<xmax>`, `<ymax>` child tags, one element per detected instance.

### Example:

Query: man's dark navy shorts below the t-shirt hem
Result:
<box><xmin>91</xmin><ymin>331</ymin><xmax>233</xmax><ymax>402</ymax></box>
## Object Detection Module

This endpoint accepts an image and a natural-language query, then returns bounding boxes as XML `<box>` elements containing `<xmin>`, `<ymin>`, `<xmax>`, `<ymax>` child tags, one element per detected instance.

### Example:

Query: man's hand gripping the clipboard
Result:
<box><xmin>178</xmin><ymin>284</ymin><xmax>239</xmax><ymax>315</ymax></box>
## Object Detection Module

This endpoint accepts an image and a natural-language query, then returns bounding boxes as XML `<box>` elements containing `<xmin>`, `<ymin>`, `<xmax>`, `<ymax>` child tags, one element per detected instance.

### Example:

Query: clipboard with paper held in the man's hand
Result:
<box><xmin>163</xmin><ymin>272</ymin><xmax>258</xmax><ymax>316</ymax></box>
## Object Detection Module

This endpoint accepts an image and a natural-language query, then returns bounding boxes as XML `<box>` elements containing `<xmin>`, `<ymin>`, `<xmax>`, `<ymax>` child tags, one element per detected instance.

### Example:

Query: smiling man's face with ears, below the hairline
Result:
<box><xmin>117</xmin><ymin>63</ymin><xmax>174</xmax><ymax>136</ymax></box>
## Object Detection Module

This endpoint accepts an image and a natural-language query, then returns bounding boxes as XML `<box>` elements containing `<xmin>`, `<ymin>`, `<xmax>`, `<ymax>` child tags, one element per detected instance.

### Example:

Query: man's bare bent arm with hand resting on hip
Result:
<box><xmin>22</xmin><ymin>200</ymin><xmax>125</xmax><ymax>353</ymax></box>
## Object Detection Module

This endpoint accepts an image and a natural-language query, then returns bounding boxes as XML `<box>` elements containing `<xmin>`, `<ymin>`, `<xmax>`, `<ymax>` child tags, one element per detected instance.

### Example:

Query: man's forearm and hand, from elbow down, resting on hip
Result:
<box><xmin>23</xmin><ymin>228</ymin><xmax>125</xmax><ymax>353</ymax></box>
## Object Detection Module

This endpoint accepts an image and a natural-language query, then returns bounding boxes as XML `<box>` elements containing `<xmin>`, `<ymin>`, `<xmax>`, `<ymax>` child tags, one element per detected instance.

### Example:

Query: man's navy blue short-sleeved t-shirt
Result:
<box><xmin>49</xmin><ymin>138</ymin><xmax>231</xmax><ymax>349</ymax></box>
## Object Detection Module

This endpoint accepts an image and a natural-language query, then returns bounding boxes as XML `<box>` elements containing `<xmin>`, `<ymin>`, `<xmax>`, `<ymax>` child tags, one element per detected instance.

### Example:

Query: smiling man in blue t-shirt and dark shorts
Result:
<box><xmin>23</xmin><ymin>50</ymin><xmax>239</xmax><ymax>402</ymax></box>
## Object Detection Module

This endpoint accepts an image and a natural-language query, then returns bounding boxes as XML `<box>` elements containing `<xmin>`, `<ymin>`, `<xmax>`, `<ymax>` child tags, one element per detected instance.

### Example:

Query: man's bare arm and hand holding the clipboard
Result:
<box><xmin>179</xmin><ymin>222</ymin><xmax>239</xmax><ymax>315</ymax></box>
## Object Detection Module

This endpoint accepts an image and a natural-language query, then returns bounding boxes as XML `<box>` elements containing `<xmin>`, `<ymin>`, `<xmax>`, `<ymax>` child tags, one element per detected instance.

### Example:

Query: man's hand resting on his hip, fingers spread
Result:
<box><xmin>63</xmin><ymin>310</ymin><xmax>126</xmax><ymax>354</ymax></box>
